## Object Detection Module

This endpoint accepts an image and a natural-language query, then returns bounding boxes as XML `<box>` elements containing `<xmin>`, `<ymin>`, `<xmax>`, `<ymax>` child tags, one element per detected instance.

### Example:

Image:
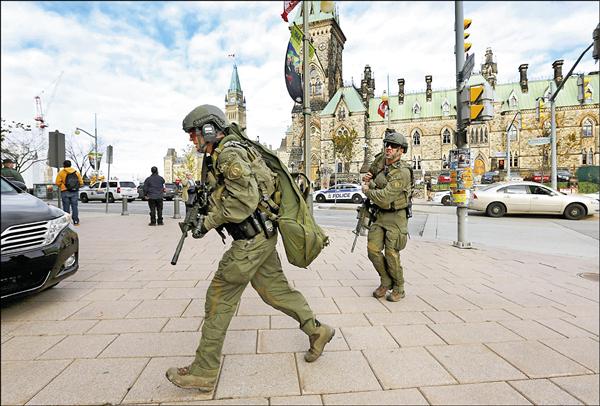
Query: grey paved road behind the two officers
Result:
<box><xmin>63</xmin><ymin>200</ymin><xmax>600</xmax><ymax>258</ymax></box>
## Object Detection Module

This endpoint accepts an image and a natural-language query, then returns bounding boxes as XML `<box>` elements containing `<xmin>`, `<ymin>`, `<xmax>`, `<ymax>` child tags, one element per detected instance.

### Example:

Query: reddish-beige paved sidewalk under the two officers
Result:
<box><xmin>1</xmin><ymin>213</ymin><xmax>600</xmax><ymax>405</ymax></box>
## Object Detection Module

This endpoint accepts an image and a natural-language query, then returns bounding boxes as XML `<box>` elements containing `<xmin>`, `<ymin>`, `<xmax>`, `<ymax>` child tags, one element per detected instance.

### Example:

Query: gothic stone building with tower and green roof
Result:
<box><xmin>278</xmin><ymin>1</ymin><xmax>600</xmax><ymax>186</ymax></box>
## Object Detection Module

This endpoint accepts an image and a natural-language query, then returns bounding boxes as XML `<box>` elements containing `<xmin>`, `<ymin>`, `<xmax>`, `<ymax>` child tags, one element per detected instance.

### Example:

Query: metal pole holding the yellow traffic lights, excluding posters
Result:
<box><xmin>453</xmin><ymin>0</ymin><xmax>471</xmax><ymax>248</ymax></box>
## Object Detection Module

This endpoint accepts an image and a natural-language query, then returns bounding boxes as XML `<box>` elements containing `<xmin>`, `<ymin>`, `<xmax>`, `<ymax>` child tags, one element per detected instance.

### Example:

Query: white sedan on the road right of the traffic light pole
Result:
<box><xmin>469</xmin><ymin>182</ymin><xmax>599</xmax><ymax>220</ymax></box>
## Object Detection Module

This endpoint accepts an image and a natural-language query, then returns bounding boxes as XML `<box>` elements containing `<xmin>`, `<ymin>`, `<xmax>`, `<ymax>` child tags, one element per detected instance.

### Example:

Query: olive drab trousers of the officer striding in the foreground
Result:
<box><xmin>190</xmin><ymin>233</ymin><xmax>317</xmax><ymax>378</ymax></box>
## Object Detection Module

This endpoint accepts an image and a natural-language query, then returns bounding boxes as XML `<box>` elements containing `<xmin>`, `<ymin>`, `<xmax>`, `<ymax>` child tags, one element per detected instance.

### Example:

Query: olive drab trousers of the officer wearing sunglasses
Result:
<box><xmin>367</xmin><ymin>210</ymin><xmax>408</xmax><ymax>291</ymax></box>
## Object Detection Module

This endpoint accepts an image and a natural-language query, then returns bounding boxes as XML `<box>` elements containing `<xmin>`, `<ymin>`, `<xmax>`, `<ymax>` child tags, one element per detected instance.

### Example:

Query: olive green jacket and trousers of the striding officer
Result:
<box><xmin>190</xmin><ymin>135</ymin><xmax>317</xmax><ymax>378</ymax></box>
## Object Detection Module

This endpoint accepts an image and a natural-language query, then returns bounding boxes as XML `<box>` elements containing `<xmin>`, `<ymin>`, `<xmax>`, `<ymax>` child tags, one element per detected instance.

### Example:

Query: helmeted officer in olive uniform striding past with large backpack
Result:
<box><xmin>166</xmin><ymin>104</ymin><xmax>335</xmax><ymax>392</ymax></box>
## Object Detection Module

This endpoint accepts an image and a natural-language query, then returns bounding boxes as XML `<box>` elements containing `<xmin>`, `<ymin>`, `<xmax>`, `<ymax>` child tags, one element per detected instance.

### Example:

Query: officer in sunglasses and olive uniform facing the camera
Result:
<box><xmin>363</xmin><ymin>129</ymin><xmax>412</xmax><ymax>302</ymax></box>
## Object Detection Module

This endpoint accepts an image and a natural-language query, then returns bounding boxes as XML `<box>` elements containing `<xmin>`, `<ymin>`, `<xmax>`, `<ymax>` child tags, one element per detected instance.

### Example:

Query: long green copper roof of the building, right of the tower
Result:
<box><xmin>369</xmin><ymin>74</ymin><xmax>600</xmax><ymax>122</ymax></box>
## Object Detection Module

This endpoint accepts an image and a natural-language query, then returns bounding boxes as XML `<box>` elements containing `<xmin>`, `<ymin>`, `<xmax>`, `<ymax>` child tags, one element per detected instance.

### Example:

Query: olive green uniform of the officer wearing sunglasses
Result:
<box><xmin>365</xmin><ymin>154</ymin><xmax>411</xmax><ymax>292</ymax></box>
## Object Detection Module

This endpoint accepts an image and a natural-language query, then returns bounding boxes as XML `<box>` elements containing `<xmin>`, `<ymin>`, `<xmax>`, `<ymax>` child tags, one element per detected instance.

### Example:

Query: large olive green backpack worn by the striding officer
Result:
<box><xmin>229</xmin><ymin>123</ymin><xmax>329</xmax><ymax>268</ymax></box>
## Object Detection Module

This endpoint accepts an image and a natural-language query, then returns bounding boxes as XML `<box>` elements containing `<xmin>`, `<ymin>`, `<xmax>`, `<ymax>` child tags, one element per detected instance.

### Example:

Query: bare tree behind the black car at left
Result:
<box><xmin>1</xmin><ymin>119</ymin><xmax>47</xmax><ymax>173</ymax></box>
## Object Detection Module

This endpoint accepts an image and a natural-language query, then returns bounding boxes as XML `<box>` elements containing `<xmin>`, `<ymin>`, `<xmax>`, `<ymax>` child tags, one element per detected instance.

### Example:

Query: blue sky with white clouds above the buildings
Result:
<box><xmin>1</xmin><ymin>1</ymin><xmax>599</xmax><ymax>180</ymax></box>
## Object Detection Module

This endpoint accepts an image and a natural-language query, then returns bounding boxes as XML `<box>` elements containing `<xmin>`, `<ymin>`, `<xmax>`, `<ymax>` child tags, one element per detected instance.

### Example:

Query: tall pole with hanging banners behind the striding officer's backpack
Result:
<box><xmin>302</xmin><ymin>0</ymin><xmax>313</xmax><ymax>213</ymax></box>
